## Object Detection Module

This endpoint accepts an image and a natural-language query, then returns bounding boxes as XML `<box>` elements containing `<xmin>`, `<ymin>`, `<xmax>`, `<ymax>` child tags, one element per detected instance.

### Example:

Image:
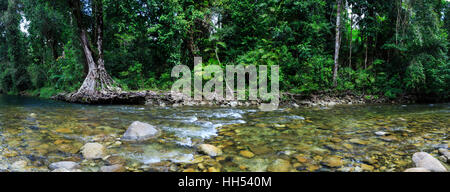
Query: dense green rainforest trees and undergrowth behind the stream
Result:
<box><xmin>0</xmin><ymin>0</ymin><xmax>450</xmax><ymax>99</ymax></box>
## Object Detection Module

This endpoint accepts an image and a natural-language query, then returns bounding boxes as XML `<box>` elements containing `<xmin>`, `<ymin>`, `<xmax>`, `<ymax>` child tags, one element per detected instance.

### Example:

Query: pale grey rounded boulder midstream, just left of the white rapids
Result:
<box><xmin>122</xmin><ymin>121</ymin><xmax>160</xmax><ymax>141</ymax></box>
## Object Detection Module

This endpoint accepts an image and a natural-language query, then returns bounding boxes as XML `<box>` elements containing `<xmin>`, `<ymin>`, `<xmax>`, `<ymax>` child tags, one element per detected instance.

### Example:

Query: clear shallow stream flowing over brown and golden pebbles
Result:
<box><xmin>0</xmin><ymin>95</ymin><xmax>450</xmax><ymax>171</ymax></box>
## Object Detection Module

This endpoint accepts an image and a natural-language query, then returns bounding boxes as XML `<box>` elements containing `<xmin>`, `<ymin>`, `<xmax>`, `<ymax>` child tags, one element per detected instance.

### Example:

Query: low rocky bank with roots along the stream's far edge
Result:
<box><xmin>52</xmin><ymin>90</ymin><xmax>418</xmax><ymax>108</ymax></box>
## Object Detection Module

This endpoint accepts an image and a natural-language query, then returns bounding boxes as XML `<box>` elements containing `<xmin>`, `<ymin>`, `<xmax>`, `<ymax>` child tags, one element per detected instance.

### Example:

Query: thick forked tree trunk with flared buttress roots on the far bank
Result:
<box><xmin>70</xmin><ymin>0</ymin><xmax>120</xmax><ymax>100</ymax></box>
